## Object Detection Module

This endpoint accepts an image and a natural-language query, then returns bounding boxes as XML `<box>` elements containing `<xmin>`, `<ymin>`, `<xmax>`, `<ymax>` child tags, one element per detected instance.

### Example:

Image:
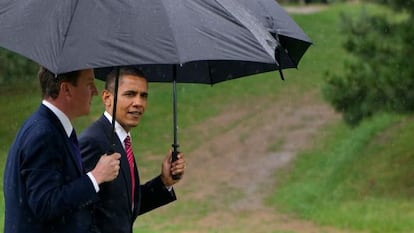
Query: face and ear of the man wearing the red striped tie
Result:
<box><xmin>102</xmin><ymin>75</ymin><xmax>148</xmax><ymax>132</ymax></box>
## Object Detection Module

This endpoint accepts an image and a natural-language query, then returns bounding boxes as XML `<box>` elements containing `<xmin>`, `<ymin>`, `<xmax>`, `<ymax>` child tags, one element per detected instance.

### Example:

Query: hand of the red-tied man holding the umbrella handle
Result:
<box><xmin>161</xmin><ymin>151</ymin><xmax>185</xmax><ymax>187</ymax></box>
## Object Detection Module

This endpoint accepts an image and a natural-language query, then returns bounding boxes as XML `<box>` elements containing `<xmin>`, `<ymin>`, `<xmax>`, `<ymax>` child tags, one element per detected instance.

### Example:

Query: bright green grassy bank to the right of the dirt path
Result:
<box><xmin>269</xmin><ymin>112</ymin><xmax>414</xmax><ymax>233</ymax></box>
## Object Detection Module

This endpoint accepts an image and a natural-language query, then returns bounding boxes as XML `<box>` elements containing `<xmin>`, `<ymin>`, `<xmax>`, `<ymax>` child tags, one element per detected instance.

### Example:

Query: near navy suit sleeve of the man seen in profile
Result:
<box><xmin>20</xmin><ymin>125</ymin><xmax>97</xmax><ymax>220</ymax></box>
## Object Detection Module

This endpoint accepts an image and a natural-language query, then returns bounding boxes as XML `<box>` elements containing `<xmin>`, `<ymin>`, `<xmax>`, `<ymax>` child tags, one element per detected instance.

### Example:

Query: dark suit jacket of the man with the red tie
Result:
<box><xmin>79</xmin><ymin>116</ymin><xmax>176</xmax><ymax>233</ymax></box>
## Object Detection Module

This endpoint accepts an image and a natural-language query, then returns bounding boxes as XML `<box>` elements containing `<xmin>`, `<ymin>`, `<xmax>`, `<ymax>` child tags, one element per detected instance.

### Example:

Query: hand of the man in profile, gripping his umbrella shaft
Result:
<box><xmin>92</xmin><ymin>153</ymin><xmax>121</xmax><ymax>184</ymax></box>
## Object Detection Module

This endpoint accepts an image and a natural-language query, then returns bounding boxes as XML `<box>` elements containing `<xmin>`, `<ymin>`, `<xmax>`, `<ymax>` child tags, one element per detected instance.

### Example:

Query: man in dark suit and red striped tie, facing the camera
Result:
<box><xmin>79</xmin><ymin>67</ymin><xmax>185</xmax><ymax>233</ymax></box>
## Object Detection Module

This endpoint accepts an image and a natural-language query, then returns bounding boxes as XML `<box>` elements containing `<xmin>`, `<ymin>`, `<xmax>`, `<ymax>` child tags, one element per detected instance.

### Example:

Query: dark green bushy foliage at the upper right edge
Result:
<box><xmin>323</xmin><ymin>0</ymin><xmax>414</xmax><ymax>125</ymax></box>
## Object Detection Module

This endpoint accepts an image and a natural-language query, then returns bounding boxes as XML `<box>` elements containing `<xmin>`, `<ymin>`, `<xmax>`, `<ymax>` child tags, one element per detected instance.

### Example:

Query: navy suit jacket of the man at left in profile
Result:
<box><xmin>3</xmin><ymin>105</ymin><xmax>97</xmax><ymax>233</ymax></box>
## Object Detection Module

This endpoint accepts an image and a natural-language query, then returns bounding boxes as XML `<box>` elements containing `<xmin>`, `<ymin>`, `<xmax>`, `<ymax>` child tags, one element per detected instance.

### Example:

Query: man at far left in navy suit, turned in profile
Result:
<box><xmin>3</xmin><ymin>68</ymin><xmax>120</xmax><ymax>233</ymax></box>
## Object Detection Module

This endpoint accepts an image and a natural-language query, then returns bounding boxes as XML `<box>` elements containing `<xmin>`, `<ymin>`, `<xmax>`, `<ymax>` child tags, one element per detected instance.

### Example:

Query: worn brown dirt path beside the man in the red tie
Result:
<box><xmin>168</xmin><ymin>92</ymin><xmax>366</xmax><ymax>233</ymax></box>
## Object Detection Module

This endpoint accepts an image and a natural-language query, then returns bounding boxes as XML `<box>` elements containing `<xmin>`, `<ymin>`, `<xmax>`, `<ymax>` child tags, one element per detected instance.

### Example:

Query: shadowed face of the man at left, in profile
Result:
<box><xmin>71</xmin><ymin>69</ymin><xmax>98</xmax><ymax>117</ymax></box>
